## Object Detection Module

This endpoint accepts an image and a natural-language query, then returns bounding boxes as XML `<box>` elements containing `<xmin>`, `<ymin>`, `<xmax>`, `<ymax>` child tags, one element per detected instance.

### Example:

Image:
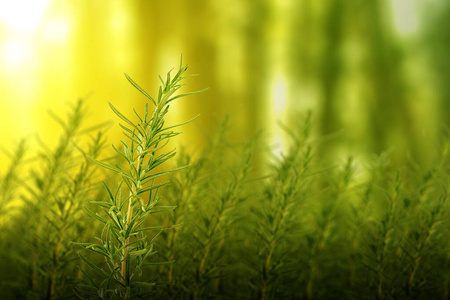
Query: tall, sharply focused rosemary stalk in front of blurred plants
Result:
<box><xmin>77</xmin><ymin>60</ymin><xmax>204</xmax><ymax>299</ymax></box>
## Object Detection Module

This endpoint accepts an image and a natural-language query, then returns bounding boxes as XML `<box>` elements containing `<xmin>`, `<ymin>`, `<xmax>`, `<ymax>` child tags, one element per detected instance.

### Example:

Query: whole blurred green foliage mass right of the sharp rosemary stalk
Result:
<box><xmin>149</xmin><ymin>116</ymin><xmax>449</xmax><ymax>299</ymax></box>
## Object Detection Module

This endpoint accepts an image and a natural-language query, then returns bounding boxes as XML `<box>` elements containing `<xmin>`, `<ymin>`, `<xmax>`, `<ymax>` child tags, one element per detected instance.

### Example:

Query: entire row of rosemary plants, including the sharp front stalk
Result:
<box><xmin>0</xmin><ymin>66</ymin><xmax>450</xmax><ymax>299</ymax></box>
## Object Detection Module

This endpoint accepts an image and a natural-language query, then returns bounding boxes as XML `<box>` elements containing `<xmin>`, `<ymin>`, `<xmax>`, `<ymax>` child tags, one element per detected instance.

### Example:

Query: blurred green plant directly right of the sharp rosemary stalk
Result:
<box><xmin>153</xmin><ymin>120</ymin><xmax>236</xmax><ymax>299</ymax></box>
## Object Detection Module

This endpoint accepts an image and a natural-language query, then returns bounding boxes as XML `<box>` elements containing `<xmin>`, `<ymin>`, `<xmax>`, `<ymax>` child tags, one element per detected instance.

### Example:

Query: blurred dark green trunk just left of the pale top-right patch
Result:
<box><xmin>355</xmin><ymin>0</ymin><xmax>419</xmax><ymax>158</ymax></box>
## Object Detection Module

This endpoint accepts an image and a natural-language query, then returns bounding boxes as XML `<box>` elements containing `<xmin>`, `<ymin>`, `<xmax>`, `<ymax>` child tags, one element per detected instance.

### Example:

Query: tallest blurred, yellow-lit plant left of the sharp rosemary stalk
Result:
<box><xmin>2</xmin><ymin>100</ymin><xmax>103</xmax><ymax>299</ymax></box>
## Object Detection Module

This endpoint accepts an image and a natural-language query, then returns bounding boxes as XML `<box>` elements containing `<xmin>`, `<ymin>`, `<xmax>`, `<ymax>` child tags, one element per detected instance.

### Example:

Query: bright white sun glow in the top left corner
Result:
<box><xmin>0</xmin><ymin>0</ymin><xmax>50</xmax><ymax>32</ymax></box>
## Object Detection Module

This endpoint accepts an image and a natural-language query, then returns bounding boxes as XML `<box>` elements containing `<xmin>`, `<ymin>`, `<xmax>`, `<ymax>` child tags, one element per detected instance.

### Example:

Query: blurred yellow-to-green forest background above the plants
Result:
<box><xmin>0</xmin><ymin>0</ymin><xmax>450</xmax><ymax>167</ymax></box>
